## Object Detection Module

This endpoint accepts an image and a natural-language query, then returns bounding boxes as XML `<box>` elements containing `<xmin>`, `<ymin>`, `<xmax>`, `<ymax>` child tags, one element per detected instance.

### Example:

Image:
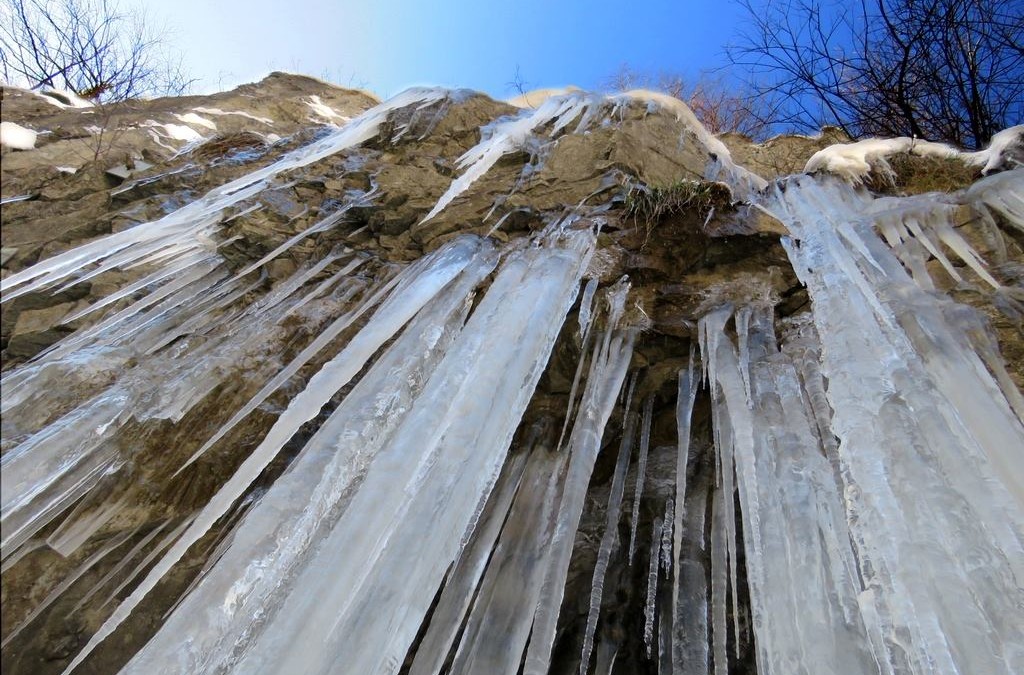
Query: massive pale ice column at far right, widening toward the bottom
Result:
<box><xmin>773</xmin><ymin>178</ymin><xmax>1024</xmax><ymax>674</ymax></box>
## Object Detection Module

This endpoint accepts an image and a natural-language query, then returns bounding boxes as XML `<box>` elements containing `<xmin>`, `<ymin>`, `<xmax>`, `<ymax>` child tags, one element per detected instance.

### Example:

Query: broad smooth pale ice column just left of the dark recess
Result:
<box><xmin>117</xmin><ymin>230</ymin><xmax>594</xmax><ymax>672</ymax></box>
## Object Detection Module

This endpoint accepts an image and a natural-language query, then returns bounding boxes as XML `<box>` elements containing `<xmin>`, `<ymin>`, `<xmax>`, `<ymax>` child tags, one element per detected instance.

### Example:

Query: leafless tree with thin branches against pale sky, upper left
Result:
<box><xmin>0</xmin><ymin>0</ymin><xmax>191</xmax><ymax>102</ymax></box>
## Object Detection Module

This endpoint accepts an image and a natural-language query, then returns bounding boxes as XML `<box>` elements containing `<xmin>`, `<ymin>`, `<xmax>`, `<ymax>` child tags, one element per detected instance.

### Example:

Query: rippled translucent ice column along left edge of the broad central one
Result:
<box><xmin>122</xmin><ymin>246</ymin><xmax>496</xmax><ymax>672</ymax></box>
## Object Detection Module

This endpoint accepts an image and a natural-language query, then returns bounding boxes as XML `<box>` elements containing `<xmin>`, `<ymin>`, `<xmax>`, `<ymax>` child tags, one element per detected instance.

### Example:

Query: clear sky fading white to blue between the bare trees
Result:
<box><xmin>142</xmin><ymin>0</ymin><xmax>742</xmax><ymax>97</ymax></box>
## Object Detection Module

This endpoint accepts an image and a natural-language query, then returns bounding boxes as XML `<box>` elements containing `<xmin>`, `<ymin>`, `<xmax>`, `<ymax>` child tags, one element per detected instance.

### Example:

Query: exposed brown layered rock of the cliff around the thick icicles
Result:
<box><xmin>0</xmin><ymin>74</ymin><xmax>1024</xmax><ymax>673</ymax></box>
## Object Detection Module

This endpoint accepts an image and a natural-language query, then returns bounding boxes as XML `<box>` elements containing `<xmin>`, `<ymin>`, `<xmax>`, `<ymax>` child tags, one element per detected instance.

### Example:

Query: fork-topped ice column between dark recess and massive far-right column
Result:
<box><xmin>701</xmin><ymin>308</ymin><xmax>878</xmax><ymax>675</ymax></box>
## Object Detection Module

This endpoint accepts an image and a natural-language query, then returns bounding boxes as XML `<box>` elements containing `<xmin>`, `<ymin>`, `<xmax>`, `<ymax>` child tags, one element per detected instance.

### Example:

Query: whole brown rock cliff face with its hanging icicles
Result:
<box><xmin>0</xmin><ymin>74</ymin><xmax>1024</xmax><ymax>675</ymax></box>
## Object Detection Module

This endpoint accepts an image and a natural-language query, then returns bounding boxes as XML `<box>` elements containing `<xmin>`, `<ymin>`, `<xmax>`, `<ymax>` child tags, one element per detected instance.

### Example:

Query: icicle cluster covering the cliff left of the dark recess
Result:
<box><xmin>0</xmin><ymin>89</ymin><xmax>663</xmax><ymax>672</ymax></box>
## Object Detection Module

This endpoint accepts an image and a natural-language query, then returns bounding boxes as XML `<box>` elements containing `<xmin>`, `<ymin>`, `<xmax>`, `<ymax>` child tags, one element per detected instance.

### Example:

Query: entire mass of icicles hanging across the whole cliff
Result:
<box><xmin>0</xmin><ymin>80</ymin><xmax>1024</xmax><ymax>675</ymax></box>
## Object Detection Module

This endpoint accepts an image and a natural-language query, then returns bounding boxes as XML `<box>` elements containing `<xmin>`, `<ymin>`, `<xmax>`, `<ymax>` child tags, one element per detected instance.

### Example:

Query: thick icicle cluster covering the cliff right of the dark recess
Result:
<box><xmin>672</xmin><ymin>170</ymin><xmax>1024</xmax><ymax>675</ymax></box>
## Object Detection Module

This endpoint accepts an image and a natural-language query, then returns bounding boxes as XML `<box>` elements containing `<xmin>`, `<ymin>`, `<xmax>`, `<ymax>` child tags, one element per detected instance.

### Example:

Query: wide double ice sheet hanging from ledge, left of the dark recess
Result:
<box><xmin>99</xmin><ymin>229</ymin><xmax>595</xmax><ymax>673</ymax></box>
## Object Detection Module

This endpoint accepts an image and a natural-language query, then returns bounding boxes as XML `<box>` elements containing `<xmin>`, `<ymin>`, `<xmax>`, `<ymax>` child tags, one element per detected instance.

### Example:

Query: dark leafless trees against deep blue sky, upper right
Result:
<box><xmin>729</xmin><ymin>0</ymin><xmax>1024</xmax><ymax>147</ymax></box>
